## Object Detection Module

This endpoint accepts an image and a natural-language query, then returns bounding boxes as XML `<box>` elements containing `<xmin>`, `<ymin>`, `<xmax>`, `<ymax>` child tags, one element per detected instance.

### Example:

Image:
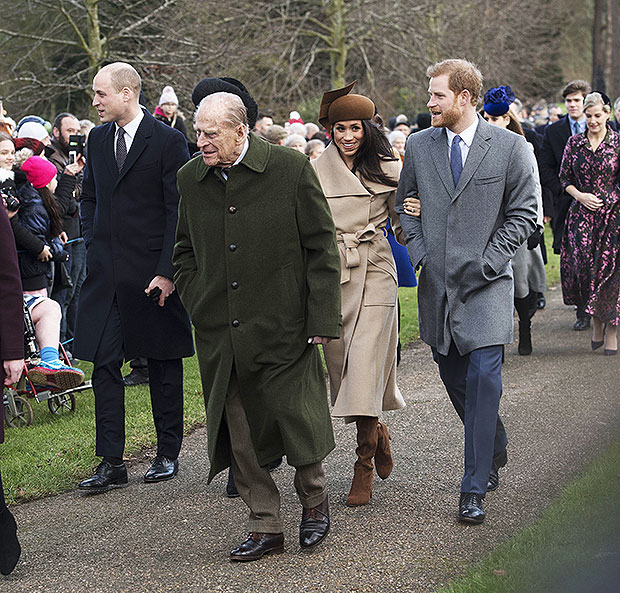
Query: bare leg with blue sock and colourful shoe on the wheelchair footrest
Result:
<box><xmin>24</xmin><ymin>294</ymin><xmax>84</xmax><ymax>390</ymax></box>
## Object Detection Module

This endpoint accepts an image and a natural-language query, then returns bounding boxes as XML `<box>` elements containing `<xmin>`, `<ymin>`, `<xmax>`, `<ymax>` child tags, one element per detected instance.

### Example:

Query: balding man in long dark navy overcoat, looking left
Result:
<box><xmin>74</xmin><ymin>62</ymin><xmax>193</xmax><ymax>492</ymax></box>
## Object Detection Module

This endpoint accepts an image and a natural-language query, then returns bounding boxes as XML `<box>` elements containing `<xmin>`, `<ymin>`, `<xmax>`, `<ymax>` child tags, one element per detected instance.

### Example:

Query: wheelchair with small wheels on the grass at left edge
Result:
<box><xmin>0</xmin><ymin>303</ymin><xmax>92</xmax><ymax>428</ymax></box>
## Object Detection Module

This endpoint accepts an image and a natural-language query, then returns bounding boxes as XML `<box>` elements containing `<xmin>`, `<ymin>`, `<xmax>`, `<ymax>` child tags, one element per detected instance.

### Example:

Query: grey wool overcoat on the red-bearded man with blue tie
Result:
<box><xmin>395</xmin><ymin>117</ymin><xmax>537</xmax><ymax>355</ymax></box>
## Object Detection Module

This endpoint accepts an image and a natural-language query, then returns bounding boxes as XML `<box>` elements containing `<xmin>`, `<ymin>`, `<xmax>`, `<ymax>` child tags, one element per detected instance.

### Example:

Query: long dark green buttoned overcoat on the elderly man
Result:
<box><xmin>173</xmin><ymin>134</ymin><xmax>341</xmax><ymax>481</ymax></box>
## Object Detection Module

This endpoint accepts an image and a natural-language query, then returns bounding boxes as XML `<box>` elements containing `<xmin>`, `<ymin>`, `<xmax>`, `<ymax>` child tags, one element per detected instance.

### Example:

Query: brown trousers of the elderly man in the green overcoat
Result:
<box><xmin>224</xmin><ymin>369</ymin><xmax>327</xmax><ymax>533</ymax></box>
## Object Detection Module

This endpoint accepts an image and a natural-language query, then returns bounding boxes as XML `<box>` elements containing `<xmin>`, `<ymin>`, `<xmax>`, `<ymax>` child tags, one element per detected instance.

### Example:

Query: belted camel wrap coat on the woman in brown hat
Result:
<box><xmin>312</xmin><ymin>143</ymin><xmax>405</xmax><ymax>421</ymax></box>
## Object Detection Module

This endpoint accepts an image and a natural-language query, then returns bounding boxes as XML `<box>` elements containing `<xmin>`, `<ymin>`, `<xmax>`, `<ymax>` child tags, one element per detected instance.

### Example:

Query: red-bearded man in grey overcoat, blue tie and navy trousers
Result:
<box><xmin>396</xmin><ymin>60</ymin><xmax>536</xmax><ymax>523</ymax></box>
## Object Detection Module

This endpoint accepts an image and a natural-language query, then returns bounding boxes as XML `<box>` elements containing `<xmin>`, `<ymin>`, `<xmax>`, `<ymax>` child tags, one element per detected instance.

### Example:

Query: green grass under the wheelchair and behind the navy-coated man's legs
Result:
<box><xmin>0</xmin><ymin>357</ymin><xmax>205</xmax><ymax>503</ymax></box>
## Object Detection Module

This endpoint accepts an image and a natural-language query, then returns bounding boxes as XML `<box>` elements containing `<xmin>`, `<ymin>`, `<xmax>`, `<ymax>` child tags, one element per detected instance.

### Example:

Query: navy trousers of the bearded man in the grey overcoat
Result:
<box><xmin>433</xmin><ymin>343</ymin><xmax>508</xmax><ymax>496</ymax></box>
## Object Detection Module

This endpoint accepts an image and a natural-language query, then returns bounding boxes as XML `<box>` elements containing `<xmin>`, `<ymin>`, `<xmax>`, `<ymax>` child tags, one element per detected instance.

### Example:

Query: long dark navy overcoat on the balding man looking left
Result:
<box><xmin>73</xmin><ymin>111</ymin><xmax>194</xmax><ymax>361</ymax></box>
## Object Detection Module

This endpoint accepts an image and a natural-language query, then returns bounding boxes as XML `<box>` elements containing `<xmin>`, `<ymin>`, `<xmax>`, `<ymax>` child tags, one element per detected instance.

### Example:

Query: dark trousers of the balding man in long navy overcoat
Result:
<box><xmin>92</xmin><ymin>298</ymin><xmax>183</xmax><ymax>459</ymax></box>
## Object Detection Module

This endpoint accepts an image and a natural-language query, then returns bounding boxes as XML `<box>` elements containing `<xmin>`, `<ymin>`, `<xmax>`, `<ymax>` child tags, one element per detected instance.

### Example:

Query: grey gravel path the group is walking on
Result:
<box><xmin>0</xmin><ymin>290</ymin><xmax>620</xmax><ymax>593</ymax></box>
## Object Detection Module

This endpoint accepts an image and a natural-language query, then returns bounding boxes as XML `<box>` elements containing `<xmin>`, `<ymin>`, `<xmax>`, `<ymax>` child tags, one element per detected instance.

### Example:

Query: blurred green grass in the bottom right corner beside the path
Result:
<box><xmin>440</xmin><ymin>441</ymin><xmax>620</xmax><ymax>593</ymax></box>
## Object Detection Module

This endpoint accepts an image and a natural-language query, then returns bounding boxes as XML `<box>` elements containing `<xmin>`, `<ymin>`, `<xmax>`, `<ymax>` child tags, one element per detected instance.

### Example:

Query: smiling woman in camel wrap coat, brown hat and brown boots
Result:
<box><xmin>312</xmin><ymin>84</ymin><xmax>405</xmax><ymax>506</ymax></box>
